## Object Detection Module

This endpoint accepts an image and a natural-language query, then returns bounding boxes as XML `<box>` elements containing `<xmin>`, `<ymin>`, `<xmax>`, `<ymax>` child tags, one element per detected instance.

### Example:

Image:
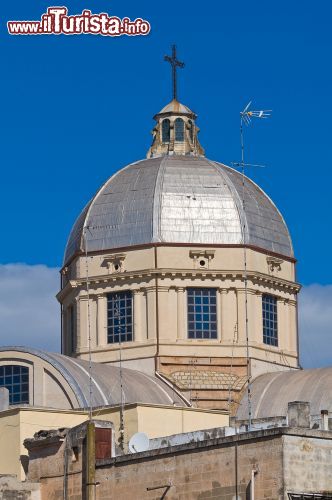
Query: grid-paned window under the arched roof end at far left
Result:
<box><xmin>0</xmin><ymin>365</ymin><xmax>29</xmax><ymax>405</ymax></box>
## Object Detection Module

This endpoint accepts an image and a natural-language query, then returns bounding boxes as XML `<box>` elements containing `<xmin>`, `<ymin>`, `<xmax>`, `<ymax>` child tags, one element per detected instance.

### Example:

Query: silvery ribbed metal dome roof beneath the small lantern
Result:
<box><xmin>64</xmin><ymin>155</ymin><xmax>293</xmax><ymax>263</ymax></box>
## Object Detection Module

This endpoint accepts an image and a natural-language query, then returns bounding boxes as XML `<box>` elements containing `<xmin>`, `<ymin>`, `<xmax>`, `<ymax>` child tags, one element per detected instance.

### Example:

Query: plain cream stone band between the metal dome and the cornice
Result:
<box><xmin>62</xmin><ymin>243</ymin><xmax>295</xmax><ymax>287</ymax></box>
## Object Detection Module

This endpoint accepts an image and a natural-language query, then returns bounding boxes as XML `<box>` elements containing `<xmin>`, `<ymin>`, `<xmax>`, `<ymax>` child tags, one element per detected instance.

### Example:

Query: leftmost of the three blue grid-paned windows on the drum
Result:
<box><xmin>107</xmin><ymin>291</ymin><xmax>133</xmax><ymax>344</ymax></box>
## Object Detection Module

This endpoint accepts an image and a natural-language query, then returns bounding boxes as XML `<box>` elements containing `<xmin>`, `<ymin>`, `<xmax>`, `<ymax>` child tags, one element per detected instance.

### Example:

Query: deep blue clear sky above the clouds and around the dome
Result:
<box><xmin>0</xmin><ymin>0</ymin><xmax>332</xmax><ymax>368</ymax></box>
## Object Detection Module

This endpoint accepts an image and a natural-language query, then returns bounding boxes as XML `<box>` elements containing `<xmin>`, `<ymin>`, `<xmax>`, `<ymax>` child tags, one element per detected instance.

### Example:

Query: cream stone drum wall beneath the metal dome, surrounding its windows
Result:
<box><xmin>58</xmin><ymin>244</ymin><xmax>299</xmax><ymax>407</ymax></box>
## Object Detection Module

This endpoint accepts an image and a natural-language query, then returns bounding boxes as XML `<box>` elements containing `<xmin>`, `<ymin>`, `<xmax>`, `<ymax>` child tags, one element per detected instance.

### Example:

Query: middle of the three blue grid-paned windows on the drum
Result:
<box><xmin>187</xmin><ymin>288</ymin><xmax>217</xmax><ymax>339</ymax></box>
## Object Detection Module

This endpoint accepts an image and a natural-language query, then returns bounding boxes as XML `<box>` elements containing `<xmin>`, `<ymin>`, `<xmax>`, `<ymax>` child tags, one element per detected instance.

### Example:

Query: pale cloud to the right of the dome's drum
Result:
<box><xmin>299</xmin><ymin>284</ymin><xmax>332</xmax><ymax>368</ymax></box>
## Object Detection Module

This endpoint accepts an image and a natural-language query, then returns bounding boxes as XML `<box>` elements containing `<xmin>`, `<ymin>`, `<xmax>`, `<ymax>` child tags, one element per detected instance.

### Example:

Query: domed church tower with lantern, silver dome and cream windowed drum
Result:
<box><xmin>58</xmin><ymin>95</ymin><xmax>300</xmax><ymax>409</ymax></box>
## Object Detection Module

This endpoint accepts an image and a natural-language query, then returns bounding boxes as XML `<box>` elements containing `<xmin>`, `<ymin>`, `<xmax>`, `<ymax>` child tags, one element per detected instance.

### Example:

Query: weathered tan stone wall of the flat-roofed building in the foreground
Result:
<box><xmin>24</xmin><ymin>428</ymin><xmax>332</xmax><ymax>500</ymax></box>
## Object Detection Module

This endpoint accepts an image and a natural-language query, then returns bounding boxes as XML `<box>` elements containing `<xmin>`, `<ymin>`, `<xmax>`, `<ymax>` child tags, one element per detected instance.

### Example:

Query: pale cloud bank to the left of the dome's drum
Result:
<box><xmin>0</xmin><ymin>264</ymin><xmax>60</xmax><ymax>351</ymax></box>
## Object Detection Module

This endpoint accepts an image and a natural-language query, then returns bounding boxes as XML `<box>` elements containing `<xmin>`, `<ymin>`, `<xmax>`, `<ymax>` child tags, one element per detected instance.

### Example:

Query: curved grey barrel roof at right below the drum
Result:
<box><xmin>236</xmin><ymin>367</ymin><xmax>332</xmax><ymax>420</ymax></box>
